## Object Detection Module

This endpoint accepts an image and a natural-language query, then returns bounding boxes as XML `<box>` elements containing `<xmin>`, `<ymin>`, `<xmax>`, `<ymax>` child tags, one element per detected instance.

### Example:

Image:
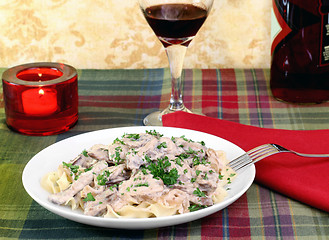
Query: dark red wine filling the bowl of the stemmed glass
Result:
<box><xmin>144</xmin><ymin>3</ymin><xmax>208</xmax><ymax>47</ymax></box>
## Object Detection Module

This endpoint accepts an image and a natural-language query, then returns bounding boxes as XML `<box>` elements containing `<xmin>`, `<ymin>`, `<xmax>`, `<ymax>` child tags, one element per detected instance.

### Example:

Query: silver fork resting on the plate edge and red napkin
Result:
<box><xmin>228</xmin><ymin>143</ymin><xmax>329</xmax><ymax>171</ymax></box>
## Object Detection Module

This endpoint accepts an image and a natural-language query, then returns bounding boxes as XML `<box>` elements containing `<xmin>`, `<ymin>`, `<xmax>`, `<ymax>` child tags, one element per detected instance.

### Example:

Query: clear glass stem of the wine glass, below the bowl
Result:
<box><xmin>166</xmin><ymin>45</ymin><xmax>187</xmax><ymax>111</ymax></box>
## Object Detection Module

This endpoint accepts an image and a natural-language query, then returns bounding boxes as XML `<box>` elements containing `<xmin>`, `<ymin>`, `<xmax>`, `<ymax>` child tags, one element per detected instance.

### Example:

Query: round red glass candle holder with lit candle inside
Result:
<box><xmin>2</xmin><ymin>62</ymin><xmax>78</xmax><ymax>136</ymax></box>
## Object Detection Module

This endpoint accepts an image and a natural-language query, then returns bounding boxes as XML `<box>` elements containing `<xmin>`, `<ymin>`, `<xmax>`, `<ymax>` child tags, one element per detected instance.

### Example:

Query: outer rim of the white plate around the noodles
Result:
<box><xmin>22</xmin><ymin>126</ymin><xmax>256</xmax><ymax>229</ymax></box>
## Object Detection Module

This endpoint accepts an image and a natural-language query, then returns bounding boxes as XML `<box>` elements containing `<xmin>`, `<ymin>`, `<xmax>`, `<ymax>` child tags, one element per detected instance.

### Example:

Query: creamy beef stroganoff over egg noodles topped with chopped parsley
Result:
<box><xmin>41</xmin><ymin>130</ymin><xmax>236</xmax><ymax>218</ymax></box>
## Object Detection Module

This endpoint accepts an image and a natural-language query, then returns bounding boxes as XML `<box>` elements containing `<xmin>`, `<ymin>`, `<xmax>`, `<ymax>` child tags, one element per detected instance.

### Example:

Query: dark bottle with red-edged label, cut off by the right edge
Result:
<box><xmin>270</xmin><ymin>0</ymin><xmax>329</xmax><ymax>104</ymax></box>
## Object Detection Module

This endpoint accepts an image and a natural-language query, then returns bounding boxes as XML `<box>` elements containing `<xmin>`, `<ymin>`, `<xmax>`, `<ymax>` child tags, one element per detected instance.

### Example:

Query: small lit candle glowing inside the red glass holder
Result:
<box><xmin>22</xmin><ymin>88</ymin><xmax>58</xmax><ymax>116</ymax></box>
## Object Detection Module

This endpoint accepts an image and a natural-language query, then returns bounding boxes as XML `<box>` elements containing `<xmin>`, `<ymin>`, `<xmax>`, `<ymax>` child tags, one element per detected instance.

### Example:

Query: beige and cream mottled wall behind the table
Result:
<box><xmin>0</xmin><ymin>0</ymin><xmax>271</xmax><ymax>69</ymax></box>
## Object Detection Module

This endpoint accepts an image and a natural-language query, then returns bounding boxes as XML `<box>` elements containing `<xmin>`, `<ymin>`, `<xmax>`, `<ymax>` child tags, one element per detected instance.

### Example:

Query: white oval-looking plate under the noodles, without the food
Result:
<box><xmin>22</xmin><ymin>127</ymin><xmax>255</xmax><ymax>229</ymax></box>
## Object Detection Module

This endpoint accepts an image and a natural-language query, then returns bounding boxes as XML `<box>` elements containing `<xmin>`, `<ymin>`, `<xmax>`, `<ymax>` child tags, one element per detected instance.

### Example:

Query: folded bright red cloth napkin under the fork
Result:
<box><xmin>162</xmin><ymin>112</ymin><xmax>329</xmax><ymax>212</ymax></box>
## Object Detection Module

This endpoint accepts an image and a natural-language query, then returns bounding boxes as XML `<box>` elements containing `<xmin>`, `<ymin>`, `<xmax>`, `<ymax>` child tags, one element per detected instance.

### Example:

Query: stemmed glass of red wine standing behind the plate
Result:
<box><xmin>138</xmin><ymin>0</ymin><xmax>213</xmax><ymax>126</ymax></box>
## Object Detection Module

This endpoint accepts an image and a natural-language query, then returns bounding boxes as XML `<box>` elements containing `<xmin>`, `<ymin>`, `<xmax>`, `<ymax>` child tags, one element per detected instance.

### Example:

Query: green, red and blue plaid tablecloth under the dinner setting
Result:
<box><xmin>0</xmin><ymin>69</ymin><xmax>329</xmax><ymax>239</ymax></box>
